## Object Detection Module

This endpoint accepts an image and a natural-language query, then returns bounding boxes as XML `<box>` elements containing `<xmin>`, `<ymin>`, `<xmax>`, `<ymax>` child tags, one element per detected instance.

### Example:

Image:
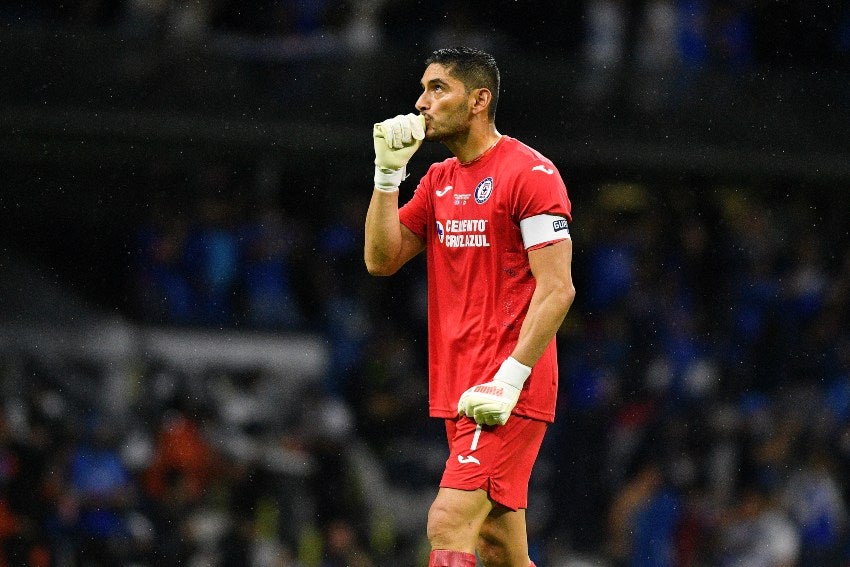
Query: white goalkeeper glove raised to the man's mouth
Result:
<box><xmin>372</xmin><ymin>113</ymin><xmax>425</xmax><ymax>192</ymax></box>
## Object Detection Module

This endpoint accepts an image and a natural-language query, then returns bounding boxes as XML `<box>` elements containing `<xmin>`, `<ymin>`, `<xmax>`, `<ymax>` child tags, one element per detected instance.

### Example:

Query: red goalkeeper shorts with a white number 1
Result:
<box><xmin>440</xmin><ymin>415</ymin><xmax>547</xmax><ymax>510</ymax></box>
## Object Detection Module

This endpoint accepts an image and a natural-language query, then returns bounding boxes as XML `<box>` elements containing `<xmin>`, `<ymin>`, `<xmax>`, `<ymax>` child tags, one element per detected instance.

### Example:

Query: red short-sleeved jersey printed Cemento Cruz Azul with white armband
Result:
<box><xmin>399</xmin><ymin>136</ymin><xmax>571</xmax><ymax>422</ymax></box>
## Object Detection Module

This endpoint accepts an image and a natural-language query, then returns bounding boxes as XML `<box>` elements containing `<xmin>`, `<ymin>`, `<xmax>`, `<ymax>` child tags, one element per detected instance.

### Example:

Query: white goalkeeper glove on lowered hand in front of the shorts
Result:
<box><xmin>457</xmin><ymin>356</ymin><xmax>531</xmax><ymax>425</ymax></box>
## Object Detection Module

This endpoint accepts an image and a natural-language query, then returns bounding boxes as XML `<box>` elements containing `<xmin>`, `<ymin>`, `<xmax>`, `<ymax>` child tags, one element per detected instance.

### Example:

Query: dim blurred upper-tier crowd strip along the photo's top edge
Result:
<box><xmin>0</xmin><ymin>0</ymin><xmax>850</xmax><ymax>65</ymax></box>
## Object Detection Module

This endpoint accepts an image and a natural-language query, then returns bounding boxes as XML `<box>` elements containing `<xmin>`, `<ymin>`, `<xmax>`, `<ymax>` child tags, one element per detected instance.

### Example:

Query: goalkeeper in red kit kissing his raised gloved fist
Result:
<box><xmin>364</xmin><ymin>47</ymin><xmax>575</xmax><ymax>567</ymax></box>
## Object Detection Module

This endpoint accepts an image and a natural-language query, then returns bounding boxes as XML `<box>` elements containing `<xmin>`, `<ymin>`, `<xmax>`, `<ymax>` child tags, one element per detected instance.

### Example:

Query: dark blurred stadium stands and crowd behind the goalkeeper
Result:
<box><xmin>0</xmin><ymin>0</ymin><xmax>850</xmax><ymax>567</ymax></box>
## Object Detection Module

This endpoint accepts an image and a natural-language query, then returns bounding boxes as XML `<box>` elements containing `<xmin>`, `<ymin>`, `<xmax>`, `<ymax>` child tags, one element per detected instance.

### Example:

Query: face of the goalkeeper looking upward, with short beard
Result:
<box><xmin>416</xmin><ymin>63</ymin><xmax>474</xmax><ymax>141</ymax></box>
